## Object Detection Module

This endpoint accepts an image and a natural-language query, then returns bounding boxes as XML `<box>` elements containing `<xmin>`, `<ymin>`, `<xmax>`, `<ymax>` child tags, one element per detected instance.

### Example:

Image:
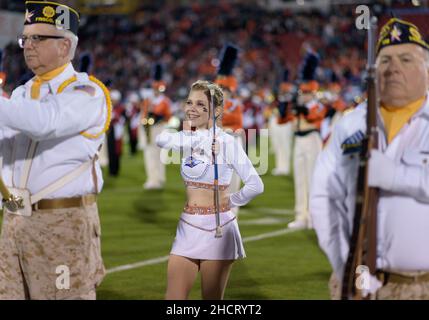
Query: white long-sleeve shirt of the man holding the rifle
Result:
<box><xmin>310</xmin><ymin>98</ymin><xmax>429</xmax><ymax>277</ymax></box>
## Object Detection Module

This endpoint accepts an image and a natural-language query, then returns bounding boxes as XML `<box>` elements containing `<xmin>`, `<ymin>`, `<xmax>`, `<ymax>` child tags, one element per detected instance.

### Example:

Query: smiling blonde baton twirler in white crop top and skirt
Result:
<box><xmin>157</xmin><ymin>81</ymin><xmax>263</xmax><ymax>299</ymax></box>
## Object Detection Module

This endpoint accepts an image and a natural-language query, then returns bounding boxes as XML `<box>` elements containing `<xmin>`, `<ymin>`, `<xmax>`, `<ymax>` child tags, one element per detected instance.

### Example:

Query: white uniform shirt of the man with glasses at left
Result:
<box><xmin>0</xmin><ymin>64</ymin><xmax>108</xmax><ymax>198</ymax></box>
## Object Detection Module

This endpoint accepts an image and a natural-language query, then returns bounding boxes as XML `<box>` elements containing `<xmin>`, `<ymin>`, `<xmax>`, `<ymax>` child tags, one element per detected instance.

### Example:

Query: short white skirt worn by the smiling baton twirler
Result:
<box><xmin>170</xmin><ymin>211</ymin><xmax>246</xmax><ymax>260</ymax></box>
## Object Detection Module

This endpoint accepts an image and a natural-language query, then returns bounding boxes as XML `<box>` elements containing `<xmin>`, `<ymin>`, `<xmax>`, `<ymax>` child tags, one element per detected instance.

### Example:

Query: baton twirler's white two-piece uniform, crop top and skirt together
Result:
<box><xmin>157</xmin><ymin>127</ymin><xmax>264</xmax><ymax>260</ymax></box>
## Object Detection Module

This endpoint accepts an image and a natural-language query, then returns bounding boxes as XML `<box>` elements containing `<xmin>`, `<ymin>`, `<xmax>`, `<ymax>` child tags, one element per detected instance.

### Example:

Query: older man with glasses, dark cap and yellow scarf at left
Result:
<box><xmin>0</xmin><ymin>1</ymin><xmax>111</xmax><ymax>299</ymax></box>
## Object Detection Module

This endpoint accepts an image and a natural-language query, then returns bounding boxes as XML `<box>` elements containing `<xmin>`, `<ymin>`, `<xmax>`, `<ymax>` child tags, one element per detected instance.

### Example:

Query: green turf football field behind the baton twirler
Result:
<box><xmin>0</xmin><ymin>139</ymin><xmax>330</xmax><ymax>299</ymax></box>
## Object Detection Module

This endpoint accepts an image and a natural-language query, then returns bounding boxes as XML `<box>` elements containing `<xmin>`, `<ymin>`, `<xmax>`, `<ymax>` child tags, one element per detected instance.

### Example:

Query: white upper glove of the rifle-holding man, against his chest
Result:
<box><xmin>368</xmin><ymin>149</ymin><xmax>396</xmax><ymax>191</ymax></box>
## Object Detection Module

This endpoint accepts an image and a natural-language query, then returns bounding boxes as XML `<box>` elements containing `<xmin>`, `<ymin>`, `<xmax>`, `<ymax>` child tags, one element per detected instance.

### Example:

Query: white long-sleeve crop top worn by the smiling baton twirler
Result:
<box><xmin>156</xmin><ymin>127</ymin><xmax>264</xmax><ymax>207</ymax></box>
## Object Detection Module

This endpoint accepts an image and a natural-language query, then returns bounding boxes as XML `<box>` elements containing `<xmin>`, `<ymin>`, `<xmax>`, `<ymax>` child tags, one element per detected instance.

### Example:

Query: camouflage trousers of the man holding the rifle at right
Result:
<box><xmin>329</xmin><ymin>273</ymin><xmax>429</xmax><ymax>300</ymax></box>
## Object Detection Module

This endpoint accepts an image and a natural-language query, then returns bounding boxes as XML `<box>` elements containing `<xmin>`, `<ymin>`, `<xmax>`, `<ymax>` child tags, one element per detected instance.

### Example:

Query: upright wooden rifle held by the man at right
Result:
<box><xmin>341</xmin><ymin>17</ymin><xmax>378</xmax><ymax>300</ymax></box>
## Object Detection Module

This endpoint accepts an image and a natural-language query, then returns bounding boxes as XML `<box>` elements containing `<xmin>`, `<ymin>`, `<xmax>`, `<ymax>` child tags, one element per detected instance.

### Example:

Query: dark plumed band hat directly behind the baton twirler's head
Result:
<box><xmin>215</xmin><ymin>44</ymin><xmax>238</xmax><ymax>92</ymax></box>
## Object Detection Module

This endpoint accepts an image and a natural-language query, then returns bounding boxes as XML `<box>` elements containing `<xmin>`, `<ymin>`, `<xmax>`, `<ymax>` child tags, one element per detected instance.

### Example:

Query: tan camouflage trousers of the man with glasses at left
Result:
<box><xmin>0</xmin><ymin>203</ymin><xmax>105</xmax><ymax>300</ymax></box>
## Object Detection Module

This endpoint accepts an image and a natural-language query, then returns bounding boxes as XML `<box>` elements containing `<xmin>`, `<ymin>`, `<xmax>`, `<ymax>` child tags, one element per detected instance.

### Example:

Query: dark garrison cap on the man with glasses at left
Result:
<box><xmin>24</xmin><ymin>1</ymin><xmax>80</xmax><ymax>35</ymax></box>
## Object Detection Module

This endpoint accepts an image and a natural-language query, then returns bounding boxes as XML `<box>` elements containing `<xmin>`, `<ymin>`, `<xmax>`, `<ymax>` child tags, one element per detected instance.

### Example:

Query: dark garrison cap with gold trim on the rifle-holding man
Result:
<box><xmin>377</xmin><ymin>18</ymin><xmax>429</xmax><ymax>54</ymax></box>
